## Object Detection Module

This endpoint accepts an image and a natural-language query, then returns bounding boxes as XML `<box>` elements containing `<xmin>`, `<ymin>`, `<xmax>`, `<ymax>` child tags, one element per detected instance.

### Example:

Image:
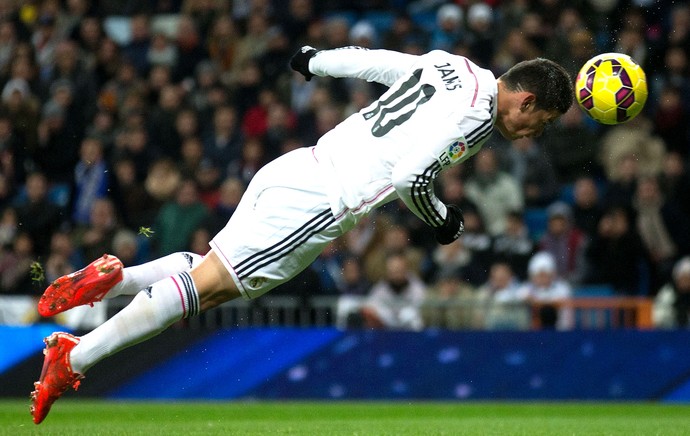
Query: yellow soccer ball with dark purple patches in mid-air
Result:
<box><xmin>575</xmin><ymin>53</ymin><xmax>647</xmax><ymax>124</ymax></box>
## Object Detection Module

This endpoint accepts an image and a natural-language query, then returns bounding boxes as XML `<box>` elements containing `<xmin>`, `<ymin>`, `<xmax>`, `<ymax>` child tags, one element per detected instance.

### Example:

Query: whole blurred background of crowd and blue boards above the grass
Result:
<box><xmin>0</xmin><ymin>0</ymin><xmax>690</xmax><ymax>401</ymax></box>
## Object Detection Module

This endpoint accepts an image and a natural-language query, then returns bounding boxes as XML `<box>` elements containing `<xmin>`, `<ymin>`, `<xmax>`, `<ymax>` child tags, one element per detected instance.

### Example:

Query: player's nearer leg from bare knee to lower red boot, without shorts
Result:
<box><xmin>31</xmin><ymin>251</ymin><xmax>240</xmax><ymax>424</ymax></box>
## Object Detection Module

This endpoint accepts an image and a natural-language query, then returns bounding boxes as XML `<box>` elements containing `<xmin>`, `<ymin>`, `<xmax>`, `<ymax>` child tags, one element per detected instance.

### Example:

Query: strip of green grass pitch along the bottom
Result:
<box><xmin>0</xmin><ymin>399</ymin><xmax>690</xmax><ymax>436</ymax></box>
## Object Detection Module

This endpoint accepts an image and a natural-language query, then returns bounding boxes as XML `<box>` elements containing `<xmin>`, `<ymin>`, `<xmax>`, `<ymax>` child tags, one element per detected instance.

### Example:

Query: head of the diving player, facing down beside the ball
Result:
<box><xmin>496</xmin><ymin>58</ymin><xmax>574</xmax><ymax>139</ymax></box>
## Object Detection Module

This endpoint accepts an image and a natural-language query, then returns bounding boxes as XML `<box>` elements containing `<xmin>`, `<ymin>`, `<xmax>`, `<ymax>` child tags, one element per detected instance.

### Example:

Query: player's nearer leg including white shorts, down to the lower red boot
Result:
<box><xmin>32</xmin><ymin>146</ymin><xmax>346</xmax><ymax>423</ymax></box>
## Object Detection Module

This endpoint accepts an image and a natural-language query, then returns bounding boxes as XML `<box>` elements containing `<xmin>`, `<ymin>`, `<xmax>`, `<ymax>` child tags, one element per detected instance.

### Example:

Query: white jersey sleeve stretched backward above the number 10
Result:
<box><xmin>309</xmin><ymin>47</ymin><xmax>419</xmax><ymax>86</ymax></box>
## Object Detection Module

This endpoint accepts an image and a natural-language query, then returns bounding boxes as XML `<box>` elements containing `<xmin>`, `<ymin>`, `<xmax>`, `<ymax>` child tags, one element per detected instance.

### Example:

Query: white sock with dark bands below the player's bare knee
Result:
<box><xmin>70</xmin><ymin>272</ymin><xmax>199</xmax><ymax>374</ymax></box>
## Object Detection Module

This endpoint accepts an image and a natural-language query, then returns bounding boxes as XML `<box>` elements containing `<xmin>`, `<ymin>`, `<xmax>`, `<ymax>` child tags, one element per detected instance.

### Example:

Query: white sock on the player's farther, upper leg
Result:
<box><xmin>105</xmin><ymin>252</ymin><xmax>203</xmax><ymax>298</ymax></box>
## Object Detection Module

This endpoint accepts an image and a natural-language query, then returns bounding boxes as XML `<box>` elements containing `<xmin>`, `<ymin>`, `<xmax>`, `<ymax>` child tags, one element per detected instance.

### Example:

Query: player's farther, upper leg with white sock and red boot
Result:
<box><xmin>38</xmin><ymin>252</ymin><xmax>202</xmax><ymax>316</ymax></box>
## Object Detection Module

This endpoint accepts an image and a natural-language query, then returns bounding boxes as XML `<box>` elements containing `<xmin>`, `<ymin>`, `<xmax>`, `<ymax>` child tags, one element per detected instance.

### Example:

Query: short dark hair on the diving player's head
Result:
<box><xmin>500</xmin><ymin>58</ymin><xmax>575</xmax><ymax>114</ymax></box>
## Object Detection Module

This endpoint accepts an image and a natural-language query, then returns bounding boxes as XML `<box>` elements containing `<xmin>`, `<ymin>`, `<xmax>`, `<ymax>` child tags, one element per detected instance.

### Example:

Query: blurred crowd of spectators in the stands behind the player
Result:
<box><xmin>0</xmin><ymin>0</ymin><xmax>690</xmax><ymax>329</ymax></box>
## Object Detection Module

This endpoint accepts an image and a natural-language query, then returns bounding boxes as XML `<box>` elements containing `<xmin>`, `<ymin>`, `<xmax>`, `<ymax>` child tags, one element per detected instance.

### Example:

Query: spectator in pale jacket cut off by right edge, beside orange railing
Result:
<box><xmin>652</xmin><ymin>256</ymin><xmax>690</xmax><ymax>329</ymax></box>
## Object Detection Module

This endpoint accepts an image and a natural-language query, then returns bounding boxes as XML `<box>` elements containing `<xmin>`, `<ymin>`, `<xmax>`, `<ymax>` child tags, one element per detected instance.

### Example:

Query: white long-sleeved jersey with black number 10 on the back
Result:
<box><xmin>309</xmin><ymin>47</ymin><xmax>497</xmax><ymax>227</ymax></box>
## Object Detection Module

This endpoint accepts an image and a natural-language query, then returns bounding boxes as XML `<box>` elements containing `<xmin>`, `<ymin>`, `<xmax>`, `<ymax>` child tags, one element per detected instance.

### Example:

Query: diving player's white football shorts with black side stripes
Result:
<box><xmin>210</xmin><ymin>148</ymin><xmax>355</xmax><ymax>299</ymax></box>
